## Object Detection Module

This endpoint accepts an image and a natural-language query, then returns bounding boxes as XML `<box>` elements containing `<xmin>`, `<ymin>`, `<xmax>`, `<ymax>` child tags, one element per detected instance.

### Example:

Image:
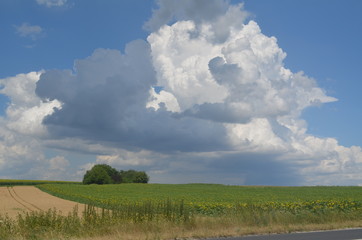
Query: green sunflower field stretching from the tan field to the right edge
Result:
<box><xmin>38</xmin><ymin>184</ymin><xmax>362</xmax><ymax>214</ymax></box>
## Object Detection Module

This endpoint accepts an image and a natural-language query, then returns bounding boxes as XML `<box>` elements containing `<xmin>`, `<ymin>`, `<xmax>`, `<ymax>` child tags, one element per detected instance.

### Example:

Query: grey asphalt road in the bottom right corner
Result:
<box><xmin>209</xmin><ymin>229</ymin><xmax>362</xmax><ymax>240</ymax></box>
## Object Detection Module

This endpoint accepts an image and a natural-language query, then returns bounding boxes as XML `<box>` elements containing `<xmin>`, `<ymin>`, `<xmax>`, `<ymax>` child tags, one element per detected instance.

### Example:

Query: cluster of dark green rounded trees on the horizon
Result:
<box><xmin>83</xmin><ymin>164</ymin><xmax>150</xmax><ymax>184</ymax></box>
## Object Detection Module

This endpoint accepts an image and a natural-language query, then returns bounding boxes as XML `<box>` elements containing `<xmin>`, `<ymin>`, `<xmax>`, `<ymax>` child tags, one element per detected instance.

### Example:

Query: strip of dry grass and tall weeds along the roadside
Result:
<box><xmin>0</xmin><ymin>200</ymin><xmax>362</xmax><ymax>240</ymax></box>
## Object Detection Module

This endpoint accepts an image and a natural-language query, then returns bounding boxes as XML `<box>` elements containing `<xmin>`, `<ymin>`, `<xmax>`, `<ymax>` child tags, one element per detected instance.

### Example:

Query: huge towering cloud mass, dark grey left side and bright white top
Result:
<box><xmin>0</xmin><ymin>0</ymin><xmax>362</xmax><ymax>185</ymax></box>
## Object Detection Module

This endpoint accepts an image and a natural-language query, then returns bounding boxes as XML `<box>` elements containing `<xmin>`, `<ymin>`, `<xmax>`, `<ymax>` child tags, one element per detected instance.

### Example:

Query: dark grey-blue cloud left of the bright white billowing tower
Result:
<box><xmin>36</xmin><ymin>40</ymin><xmax>225</xmax><ymax>151</ymax></box>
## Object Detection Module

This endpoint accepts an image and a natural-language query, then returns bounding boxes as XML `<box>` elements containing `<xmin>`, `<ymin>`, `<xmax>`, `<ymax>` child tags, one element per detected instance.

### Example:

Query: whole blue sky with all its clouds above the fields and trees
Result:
<box><xmin>0</xmin><ymin>0</ymin><xmax>362</xmax><ymax>186</ymax></box>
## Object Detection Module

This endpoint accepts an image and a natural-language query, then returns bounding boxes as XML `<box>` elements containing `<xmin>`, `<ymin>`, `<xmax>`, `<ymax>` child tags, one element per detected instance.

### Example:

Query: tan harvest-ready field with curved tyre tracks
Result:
<box><xmin>0</xmin><ymin>186</ymin><xmax>84</xmax><ymax>217</ymax></box>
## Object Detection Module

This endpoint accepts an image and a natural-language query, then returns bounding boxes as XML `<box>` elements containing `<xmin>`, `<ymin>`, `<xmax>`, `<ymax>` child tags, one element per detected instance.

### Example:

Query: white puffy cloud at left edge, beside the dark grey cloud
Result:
<box><xmin>0</xmin><ymin>72</ymin><xmax>65</xmax><ymax>179</ymax></box>
